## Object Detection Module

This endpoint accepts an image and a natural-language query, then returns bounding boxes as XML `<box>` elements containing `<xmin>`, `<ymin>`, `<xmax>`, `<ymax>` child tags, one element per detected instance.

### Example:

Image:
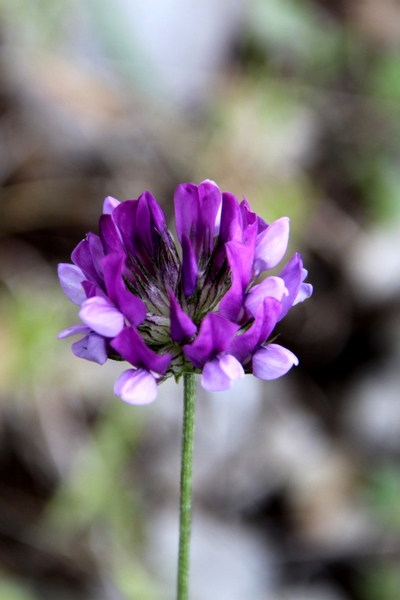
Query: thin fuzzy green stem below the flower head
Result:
<box><xmin>177</xmin><ymin>373</ymin><xmax>196</xmax><ymax>600</ymax></box>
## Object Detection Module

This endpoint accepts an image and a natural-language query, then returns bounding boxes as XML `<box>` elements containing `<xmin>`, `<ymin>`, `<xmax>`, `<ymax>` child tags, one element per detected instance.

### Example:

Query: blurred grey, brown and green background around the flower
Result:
<box><xmin>0</xmin><ymin>0</ymin><xmax>400</xmax><ymax>600</ymax></box>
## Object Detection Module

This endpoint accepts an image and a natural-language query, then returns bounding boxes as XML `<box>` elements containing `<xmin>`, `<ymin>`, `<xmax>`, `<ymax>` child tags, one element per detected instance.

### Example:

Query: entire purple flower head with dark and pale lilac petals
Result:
<box><xmin>58</xmin><ymin>180</ymin><xmax>313</xmax><ymax>404</ymax></box>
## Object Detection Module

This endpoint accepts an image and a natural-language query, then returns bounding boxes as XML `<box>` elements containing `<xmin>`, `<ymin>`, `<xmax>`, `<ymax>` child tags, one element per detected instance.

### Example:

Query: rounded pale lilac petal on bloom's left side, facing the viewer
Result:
<box><xmin>79</xmin><ymin>296</ymin><xmax>124</xmax><ymax>338</ymax></box>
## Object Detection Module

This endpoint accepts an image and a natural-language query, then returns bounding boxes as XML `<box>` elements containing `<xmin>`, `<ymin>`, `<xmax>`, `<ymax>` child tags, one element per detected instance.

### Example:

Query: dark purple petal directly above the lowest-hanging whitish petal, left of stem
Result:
<box><xmin>111</xmin><ymin>327</ymin><xmax>172</xmax><ymax>376</ymax></box>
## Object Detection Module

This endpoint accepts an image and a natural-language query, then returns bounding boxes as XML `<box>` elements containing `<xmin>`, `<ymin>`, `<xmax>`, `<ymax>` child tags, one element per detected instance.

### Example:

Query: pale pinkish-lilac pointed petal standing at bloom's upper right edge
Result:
<box><xmin>254</xmin><ymin>217</ymin><xmax>290</xmax><ymax>275</ymax></box>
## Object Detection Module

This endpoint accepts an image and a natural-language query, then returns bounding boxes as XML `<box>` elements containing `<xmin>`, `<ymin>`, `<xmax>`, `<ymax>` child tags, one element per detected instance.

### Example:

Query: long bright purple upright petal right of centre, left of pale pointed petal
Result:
<box><xmin>219</xmin><ymin>242</ymin><xmax>254</xmax><ymax>321</ymax></box>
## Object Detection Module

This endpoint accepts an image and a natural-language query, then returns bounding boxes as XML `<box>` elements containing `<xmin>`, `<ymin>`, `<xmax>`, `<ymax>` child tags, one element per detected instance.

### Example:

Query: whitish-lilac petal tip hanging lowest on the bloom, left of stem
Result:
<box><xmin>114</xmin><ymin>369</ymin><xmax>157</xmax><ymax>405</ymax></box>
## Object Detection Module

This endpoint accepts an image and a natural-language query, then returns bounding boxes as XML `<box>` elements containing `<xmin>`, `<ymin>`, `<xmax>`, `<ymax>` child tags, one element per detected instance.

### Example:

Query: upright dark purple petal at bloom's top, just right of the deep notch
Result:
<box><xmin>174</xmin><ymin>183</ymin><xmax>199</xmax><ymax>244</ymax></box>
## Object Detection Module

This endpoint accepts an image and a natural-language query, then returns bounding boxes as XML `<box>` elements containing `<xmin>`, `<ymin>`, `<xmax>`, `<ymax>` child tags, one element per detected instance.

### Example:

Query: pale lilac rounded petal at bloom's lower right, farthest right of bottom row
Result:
<box><xmin>253</xmin><ymin>344</ymin><xmax>299</xmax><ymax>380</ymax></box>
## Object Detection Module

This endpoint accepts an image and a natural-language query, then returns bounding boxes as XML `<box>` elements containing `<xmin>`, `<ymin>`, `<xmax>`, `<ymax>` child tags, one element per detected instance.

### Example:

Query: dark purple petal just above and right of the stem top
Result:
<box><xmin>182</xmin><ymin>313</ymin><xmax>239</xmax><ymax>369</ymax></box>
